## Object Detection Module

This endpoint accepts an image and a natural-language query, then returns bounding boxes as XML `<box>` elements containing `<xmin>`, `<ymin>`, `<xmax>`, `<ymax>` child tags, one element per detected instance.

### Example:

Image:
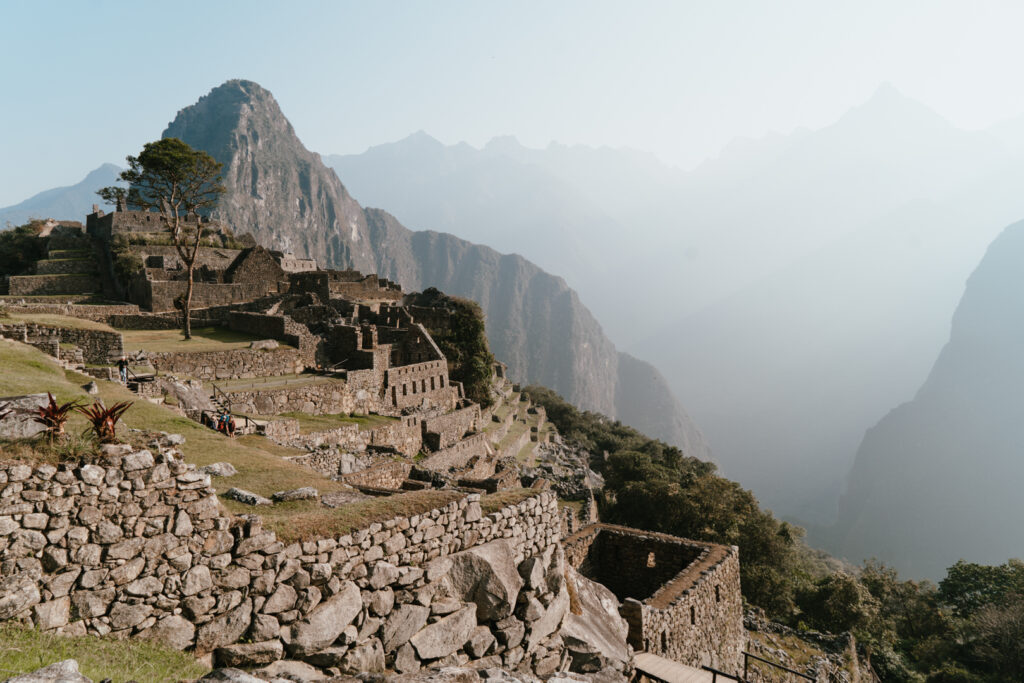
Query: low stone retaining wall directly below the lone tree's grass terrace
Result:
<box><xmin>145</xmin><ymin>348</ymin><xmax>305</xmax><ymax>382</ymax></box>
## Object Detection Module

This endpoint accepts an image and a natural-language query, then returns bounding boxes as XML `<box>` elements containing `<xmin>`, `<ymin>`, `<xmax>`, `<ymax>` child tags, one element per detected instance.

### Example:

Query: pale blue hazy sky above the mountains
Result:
<box><xmin>0</xmin><ymin>0</ymin><xmax>1024</xmax><ymax>206</ymax></box>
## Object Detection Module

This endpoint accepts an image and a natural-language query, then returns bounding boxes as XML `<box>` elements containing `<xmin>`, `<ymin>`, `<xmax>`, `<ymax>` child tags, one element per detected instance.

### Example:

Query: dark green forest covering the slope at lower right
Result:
<box><xmin>524</xmin><ymin>386</ymin><xmax>1024</xmax><ymax>683</ymax></box>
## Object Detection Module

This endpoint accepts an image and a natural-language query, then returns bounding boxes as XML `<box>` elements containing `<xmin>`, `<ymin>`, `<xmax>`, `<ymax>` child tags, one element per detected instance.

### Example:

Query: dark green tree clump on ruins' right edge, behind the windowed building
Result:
<box><xmin>415</xmin><ymin>287</ymin><xmax>495</xmax><ymax>408</ymax></box>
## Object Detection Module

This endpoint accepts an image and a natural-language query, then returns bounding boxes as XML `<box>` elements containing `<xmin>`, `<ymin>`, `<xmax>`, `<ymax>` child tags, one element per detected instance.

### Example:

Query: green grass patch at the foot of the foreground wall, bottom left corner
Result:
<box><xmin>0</xmin><ymin>626</ymin><xmax>208</xmax><ymax>683</ymax></box>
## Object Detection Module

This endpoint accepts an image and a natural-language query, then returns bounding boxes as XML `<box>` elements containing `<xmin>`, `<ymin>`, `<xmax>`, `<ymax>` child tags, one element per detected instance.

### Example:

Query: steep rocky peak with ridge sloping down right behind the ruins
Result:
<box><xmin>164</xmin><ymin>81</ymin><xmax>708</xmax><ymax>457</ymax></box>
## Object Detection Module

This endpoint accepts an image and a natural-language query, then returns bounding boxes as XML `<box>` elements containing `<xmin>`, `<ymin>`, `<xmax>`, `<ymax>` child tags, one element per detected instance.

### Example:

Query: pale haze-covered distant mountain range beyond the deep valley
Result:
<box><xmin>326</xmin><ymin>85</ymin><xmax>1024</xmax><ymax>523</ymax></box>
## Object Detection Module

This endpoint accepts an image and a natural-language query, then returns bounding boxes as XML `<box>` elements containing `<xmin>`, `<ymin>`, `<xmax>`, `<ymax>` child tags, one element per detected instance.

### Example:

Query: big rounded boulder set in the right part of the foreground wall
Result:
<box><xmin>447</xmin><ymin>539</ymin><xmax>522</xmax><ymax>622</ymax></box>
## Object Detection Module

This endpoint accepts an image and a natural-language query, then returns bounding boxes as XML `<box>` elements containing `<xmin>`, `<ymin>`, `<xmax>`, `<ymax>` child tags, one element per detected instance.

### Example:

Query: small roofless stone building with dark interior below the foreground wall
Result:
<box><xmin>563</xmin><ymin>524</ymin><xmax>745</xmax><ymax>672</ymax></box>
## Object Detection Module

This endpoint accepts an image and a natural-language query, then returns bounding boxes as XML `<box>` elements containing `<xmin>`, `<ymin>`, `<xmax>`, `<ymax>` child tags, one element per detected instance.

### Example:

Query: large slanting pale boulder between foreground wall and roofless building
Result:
<box><xmin>561</xmin><ymin>567</ymin><xmax>630</xmax><ymax>673</ymax></box>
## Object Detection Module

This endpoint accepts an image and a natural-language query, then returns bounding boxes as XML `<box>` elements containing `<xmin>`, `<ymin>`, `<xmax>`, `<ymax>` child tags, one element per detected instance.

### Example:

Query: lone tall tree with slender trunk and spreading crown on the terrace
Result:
<box><xmin>97</xmin><ymin>137</ymin><xmax>225</xmax><ymax>339</ymax></box>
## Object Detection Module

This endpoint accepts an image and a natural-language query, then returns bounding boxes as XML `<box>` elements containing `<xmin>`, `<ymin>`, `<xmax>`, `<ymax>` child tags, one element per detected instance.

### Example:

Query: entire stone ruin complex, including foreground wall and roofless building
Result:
<box><xmin>0</xmin><ymin>201</ymin><xmax>743</xmax><ymax>676</ymax></box>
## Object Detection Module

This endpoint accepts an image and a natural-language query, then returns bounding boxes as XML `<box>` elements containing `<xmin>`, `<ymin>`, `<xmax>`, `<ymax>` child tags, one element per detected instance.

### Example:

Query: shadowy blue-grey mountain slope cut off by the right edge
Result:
<box><xmin>834</xmin><ymin>222</ymin><xmax>1024</xmax><ymax>578</ymax></box>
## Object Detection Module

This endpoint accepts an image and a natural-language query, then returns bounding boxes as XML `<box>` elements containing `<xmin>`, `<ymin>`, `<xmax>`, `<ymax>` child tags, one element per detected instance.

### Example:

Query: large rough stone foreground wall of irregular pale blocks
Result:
<box><xmin>0</xmin><ymin>446</ymin><xmax>568</xmax><ymax>673</ymax></box>
